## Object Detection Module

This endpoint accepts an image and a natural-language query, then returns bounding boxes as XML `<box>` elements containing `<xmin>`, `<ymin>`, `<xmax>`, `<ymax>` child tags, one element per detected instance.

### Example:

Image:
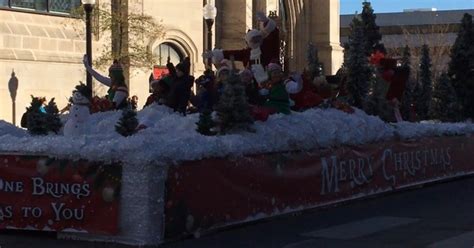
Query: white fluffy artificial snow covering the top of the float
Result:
<box><xmin>0</xmin><ymin>105</ymin><xmax>474</xmax><ymax>164</ymax></box>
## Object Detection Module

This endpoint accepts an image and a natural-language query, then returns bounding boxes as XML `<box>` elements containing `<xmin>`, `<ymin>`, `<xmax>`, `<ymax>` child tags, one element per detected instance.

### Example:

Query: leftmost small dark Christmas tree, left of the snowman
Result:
<box><xmin>22</xmin><ymin>96</ymin><xmax>49</xmax><ymax>135</ymax></box>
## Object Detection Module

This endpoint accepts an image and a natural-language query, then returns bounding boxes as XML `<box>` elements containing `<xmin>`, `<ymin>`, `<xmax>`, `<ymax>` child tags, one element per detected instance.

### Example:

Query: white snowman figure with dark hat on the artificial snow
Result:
<box><xmin>64</xmin><ymin>83</ymin><xmax>92</xmax><ymax>136</ymax></box>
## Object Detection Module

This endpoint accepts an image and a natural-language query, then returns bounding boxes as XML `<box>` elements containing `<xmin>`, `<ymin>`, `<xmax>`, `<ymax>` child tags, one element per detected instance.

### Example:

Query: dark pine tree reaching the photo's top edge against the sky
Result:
<box><xmin>361</xmin><ymin>1</ymin><xmax>385</xmax><ymax>56</ymax></box>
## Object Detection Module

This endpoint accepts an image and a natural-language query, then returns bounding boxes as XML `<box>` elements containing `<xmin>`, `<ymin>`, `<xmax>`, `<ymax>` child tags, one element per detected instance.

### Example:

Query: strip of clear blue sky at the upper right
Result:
<box><xmin>340</xmin><ymin>0</ymin><xmax>474</xmax><ymax>15</ymax></box>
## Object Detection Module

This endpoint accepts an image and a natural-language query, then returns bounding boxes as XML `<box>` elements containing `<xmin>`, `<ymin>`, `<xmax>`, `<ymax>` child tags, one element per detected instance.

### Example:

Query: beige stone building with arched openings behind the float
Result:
<box><xmin>0</xmin><ymin>0</ymin><xmax>342</xmax><ymax>122</ymax></box>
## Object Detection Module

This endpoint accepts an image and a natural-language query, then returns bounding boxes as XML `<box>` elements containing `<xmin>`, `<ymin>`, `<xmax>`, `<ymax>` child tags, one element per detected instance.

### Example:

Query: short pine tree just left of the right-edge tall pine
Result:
<box><xmin>430</xmin><ymin>73</ymin><xmax>461</xmax><ymax>122</ymax></box>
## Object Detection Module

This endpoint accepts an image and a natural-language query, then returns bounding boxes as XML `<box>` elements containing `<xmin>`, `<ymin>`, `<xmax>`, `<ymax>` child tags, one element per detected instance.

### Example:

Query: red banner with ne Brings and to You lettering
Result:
<box><xmin>0</xmin><ymin>155</ymin><xmax>122</xmax><ymax>234</ymax></box>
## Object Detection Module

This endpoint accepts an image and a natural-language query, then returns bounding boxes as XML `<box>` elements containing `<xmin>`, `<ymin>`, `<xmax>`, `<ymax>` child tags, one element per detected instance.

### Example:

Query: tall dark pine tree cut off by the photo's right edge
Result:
<box><xmin>448</xmin><ymin>13</ymin><xmax>474</xmax><ymax>119</ymax></box>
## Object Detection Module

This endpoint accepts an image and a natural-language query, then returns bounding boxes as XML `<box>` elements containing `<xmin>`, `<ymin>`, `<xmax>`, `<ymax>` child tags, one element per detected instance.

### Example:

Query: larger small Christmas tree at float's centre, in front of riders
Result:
<box><xmin>216</xmin><ymin>61</ymin><xmax>253</xmax><ymax>134</ymax></box>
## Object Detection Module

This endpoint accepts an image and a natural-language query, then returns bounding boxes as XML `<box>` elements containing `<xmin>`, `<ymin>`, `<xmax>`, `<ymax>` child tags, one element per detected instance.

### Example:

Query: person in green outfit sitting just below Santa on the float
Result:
<box><xmin>263</xmin><ymin>63</ymin><xmax>291</xmax><ymax>114</ymax></box>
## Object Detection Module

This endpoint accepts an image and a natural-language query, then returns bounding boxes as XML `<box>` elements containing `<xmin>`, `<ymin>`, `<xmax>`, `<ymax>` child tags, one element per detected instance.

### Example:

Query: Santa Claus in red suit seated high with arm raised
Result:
<box><xmin>207</xmin><ymin>12</ymin><xmax>280</xmax><ymax>80</ymax></box>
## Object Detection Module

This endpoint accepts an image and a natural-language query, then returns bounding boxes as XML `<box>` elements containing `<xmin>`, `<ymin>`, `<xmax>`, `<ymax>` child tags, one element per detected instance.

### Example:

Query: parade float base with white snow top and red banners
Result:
<box><xmin>0</xmin><ymin>102</ymin><xmax>474</xmax><ymax>245</ymax></box>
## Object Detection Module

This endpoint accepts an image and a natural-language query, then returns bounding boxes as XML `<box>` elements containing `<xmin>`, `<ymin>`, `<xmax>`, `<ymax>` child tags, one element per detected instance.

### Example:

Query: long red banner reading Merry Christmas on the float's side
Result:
<box><xmin>165</xmin><ymin>137</ymin><xmax>474</xmax><ymax>238</ymax></box>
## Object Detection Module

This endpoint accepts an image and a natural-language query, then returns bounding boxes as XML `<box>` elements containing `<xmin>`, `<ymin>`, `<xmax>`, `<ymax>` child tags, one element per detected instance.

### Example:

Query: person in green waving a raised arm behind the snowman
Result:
<box><xmin>82</xmin><ymin>55</ymin><xmax>128</xmax><ymax>109</ymax></box>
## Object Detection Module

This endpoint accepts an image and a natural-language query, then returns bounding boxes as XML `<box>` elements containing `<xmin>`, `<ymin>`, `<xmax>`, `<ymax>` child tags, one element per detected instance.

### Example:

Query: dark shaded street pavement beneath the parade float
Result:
<box><xmin>0</xmin><ymin>177</ymin><xmax>474</xmax><ymax>248</ymax></box>
